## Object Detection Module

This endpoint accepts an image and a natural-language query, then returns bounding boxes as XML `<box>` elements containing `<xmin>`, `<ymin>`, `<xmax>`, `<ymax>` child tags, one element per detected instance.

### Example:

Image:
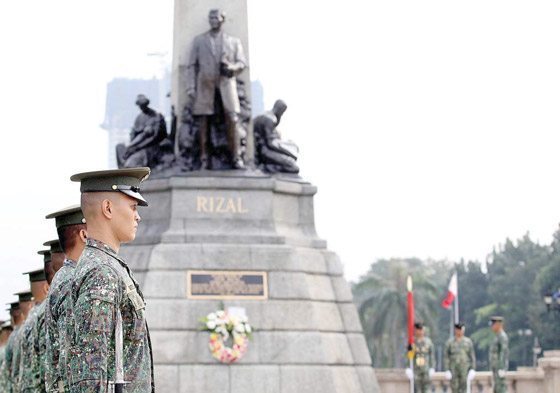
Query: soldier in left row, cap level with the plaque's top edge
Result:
<box><xmin>17</xmin><ymin>268</ymin><xmax>49</xmax><ymax>392</ymax></box>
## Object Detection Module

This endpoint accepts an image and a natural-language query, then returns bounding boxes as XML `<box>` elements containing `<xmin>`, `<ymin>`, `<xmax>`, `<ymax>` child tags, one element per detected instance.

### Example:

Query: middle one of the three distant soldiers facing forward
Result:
<box><xmin>443</xmin><ymin>323</ymin><xmax>476</xmax><ymax>393</ymax></box>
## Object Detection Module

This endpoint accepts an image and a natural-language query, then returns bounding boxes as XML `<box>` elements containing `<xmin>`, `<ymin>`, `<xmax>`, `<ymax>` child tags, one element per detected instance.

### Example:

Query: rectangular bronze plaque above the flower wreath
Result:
<box><xmin>187</xmin><ymin>270</ymin><xmax>268</xmax><ymax>299</ymax></box>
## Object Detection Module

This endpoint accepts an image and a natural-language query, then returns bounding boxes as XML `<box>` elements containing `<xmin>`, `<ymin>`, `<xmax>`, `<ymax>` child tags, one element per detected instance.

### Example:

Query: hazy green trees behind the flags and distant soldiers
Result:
<box><xmin>353</xmin><ymin>231</ymin><xmax>560</xmax><ymax>369</ymax></box>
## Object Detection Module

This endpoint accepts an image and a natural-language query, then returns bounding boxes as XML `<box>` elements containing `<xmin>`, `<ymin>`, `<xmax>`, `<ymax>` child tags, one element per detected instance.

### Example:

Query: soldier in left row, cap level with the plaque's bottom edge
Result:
<box><xmin>6</xmin><ymin>290</ymin><xmax>35</xmax><ymax>393</ymax></box>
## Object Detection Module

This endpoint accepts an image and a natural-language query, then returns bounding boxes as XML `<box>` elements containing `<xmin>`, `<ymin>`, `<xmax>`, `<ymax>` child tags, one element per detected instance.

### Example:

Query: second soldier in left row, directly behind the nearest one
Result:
<box><xmin>45</xmin><ymin>205</ymin><xmax>87</xmax><ymax>392</ymax></box>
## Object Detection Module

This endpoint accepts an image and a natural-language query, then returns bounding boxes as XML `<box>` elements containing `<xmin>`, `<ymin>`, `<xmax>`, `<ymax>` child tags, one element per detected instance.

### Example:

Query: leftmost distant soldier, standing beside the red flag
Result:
<box><xmin>413</xmin><ymin>323</ymin><xmax>436</xmax><ymax>393</ymax></box>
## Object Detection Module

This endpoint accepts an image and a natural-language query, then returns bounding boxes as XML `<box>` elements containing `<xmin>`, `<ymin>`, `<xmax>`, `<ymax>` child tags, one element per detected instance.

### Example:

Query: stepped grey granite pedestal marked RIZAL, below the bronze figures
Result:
<box><xmin>122</xmin><ymin>172</ymin><xmax>379</xmax><ymax>393</ymax></box>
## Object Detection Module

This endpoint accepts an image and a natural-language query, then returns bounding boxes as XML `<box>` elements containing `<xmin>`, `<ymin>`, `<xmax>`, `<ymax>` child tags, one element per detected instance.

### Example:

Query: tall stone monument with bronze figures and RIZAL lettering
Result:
<box><xmin>117</xmin><ymin>0</ymin><xmax>379</xmax><ymax>393</ymax></box>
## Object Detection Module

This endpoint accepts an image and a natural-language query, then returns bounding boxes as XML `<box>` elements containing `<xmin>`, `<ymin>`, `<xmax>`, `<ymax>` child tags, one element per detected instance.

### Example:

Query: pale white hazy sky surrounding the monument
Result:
<box><xmin>0</xmin><ymin>0</ymin><xmax>560</xmax><ymax>317</ymax></box>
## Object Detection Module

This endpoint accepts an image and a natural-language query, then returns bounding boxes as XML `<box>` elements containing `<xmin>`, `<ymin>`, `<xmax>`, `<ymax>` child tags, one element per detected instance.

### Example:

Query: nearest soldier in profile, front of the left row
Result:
<box><xmin>69</xmin><ymin>168</ymin><xmax>155</xmax><ymax>393</ymax></box>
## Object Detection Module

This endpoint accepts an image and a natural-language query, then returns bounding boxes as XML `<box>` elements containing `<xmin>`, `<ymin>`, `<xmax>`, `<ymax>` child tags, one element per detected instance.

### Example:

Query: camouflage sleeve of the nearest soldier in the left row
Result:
<box><xmin>70</xmin><ymin>265</ymin><xmax>122</xmax><ymax>393</ymax></box>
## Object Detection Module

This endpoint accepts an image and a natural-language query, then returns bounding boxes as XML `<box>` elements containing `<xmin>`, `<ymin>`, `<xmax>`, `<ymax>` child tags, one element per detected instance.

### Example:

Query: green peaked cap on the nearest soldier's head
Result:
<box><xmin>70</xmin><ymin>167</ymin><xmax>150</xmax><ymax>206</ymax></box>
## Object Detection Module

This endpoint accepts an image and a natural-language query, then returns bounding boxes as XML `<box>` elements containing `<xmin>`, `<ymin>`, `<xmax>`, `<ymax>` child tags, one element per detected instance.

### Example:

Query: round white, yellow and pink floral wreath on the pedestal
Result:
<box><xmin>201</xmin><ymin>310</ymin><xmax>253</xmax><ymax>364</ymax></box>
